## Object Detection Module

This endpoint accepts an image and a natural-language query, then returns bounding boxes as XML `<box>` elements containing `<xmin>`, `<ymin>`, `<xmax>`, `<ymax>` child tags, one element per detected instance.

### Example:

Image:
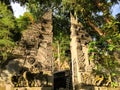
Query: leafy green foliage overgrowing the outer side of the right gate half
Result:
<box><xmin>89</xmin><ymin>38</ymin><xmax>120</xmax><ymax>87</ymax></box>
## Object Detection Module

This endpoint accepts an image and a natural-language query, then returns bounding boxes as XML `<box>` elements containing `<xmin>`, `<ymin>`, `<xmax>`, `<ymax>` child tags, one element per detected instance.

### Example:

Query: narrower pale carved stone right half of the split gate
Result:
<box><xmin>70</xmin><ymin>14</ymin><xmax>92</xmax><ymax>90</ymax></box>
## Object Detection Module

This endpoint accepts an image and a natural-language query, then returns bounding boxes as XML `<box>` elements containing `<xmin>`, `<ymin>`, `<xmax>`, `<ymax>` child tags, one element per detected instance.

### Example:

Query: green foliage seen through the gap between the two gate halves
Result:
<box><xmin>53</xmin><ymin>9</ymin><xmax>70</xmax><ymax>62</ymax></box>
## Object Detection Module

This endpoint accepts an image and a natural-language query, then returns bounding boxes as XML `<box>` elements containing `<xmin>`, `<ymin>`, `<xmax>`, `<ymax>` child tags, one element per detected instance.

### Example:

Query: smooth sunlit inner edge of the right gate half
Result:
<box><xmin>70</xmin><ymin>15</ymin><xmax>79</xmax><ymax>90</ymax></box>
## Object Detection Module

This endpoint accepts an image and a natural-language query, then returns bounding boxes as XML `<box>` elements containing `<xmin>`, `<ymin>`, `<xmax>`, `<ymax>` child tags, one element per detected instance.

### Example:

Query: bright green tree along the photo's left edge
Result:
<box><xmin>0</xmin><ymin>2</ymin><xmax>15</xmax><ymax>63</ymax></box>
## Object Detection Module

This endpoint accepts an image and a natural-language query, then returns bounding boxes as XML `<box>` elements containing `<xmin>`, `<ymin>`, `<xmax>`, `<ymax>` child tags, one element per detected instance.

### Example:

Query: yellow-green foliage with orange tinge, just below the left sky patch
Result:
<box><xmin>12</xmin><ymin>12</ymin><xmax>34</xmax><ymax>41</ymax></box>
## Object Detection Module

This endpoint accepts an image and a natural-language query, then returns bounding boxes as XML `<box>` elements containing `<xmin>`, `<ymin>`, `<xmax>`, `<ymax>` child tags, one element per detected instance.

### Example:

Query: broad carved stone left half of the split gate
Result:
<box><xmin>1</xmin><ymin>10</ymin><xmax>53</xmax><ymax>86</ymax></box>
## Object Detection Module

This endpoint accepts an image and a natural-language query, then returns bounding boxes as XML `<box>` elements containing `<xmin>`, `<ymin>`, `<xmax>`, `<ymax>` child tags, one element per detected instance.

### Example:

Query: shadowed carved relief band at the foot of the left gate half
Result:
<box><xmin>11</xmin><ymin>71</ymin><xmax>48</xmax><ymax>87</ymax></box>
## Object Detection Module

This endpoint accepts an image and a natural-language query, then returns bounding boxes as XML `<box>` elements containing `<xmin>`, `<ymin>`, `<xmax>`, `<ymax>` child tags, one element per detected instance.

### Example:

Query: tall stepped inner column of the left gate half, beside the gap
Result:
<box><xmin>36</xmin><ymin>10</ymin><xmax>53</xmax><ymax>71</ymax></box>
